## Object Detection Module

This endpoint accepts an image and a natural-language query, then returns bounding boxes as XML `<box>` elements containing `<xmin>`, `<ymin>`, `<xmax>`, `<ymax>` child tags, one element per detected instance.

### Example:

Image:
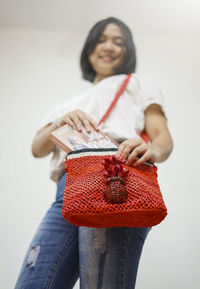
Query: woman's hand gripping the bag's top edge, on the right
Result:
<box><xmin>117</xmin><ymin>138</ymin><xmax>161</xmax><ymax>166</ymax></box>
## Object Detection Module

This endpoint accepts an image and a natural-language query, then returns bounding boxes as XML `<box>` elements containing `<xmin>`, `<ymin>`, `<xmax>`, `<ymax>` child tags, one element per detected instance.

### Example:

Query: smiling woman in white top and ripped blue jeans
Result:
<box><xmin>15</xmin><ymin>17</ymin><xmax>173</xmax><ymax>289</ymax></box>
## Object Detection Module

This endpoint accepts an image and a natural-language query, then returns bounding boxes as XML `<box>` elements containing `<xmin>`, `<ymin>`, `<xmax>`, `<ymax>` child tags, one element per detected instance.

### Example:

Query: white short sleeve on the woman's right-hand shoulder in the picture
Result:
<box><xmin>137</xmin><ymin>75</ymin><xmax>167</xmax><ymax>120</ymax></box>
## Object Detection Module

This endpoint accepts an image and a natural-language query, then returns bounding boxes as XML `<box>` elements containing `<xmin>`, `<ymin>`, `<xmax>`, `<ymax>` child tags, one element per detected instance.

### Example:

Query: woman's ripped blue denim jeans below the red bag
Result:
<box><xmin>15</xmin><ymin>174</ymin><xmax>151</xmax><ymax>289</ymax></box>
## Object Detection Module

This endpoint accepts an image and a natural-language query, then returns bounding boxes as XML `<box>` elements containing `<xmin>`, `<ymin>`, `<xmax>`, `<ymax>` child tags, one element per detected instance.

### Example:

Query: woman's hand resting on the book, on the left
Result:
<box><xmin>56</xmin><ymin>109</ymin><xmax>99</xmax><ymax>133</ymax></box>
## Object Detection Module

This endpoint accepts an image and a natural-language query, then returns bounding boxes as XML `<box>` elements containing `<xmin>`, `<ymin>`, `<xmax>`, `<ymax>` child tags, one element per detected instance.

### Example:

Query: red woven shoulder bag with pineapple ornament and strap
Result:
<box><xmin>62</xmin><ymin>74</ymin><xmax>167</xmax><ymax>228</ymax></box>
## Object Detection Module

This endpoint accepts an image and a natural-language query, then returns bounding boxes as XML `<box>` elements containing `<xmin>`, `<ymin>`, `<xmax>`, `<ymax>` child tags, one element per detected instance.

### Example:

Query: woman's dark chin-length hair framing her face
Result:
<box><xmin>80</xmin><ymin>17</ymin><xmax>136</xmax><ymax>82</ymax></box>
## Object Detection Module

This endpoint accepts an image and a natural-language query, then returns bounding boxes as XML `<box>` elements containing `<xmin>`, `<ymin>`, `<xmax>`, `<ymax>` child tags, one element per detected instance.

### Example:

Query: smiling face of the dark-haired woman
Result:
<box><xmin>89</xmin><ymin>23</ymin><xmax>126</xmax><ymax>83</ymax></box>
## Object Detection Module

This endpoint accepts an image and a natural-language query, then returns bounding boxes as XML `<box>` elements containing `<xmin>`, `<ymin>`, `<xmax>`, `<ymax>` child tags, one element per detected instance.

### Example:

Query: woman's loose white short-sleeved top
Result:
<box><xmin>41</xmin><ymin>73</ymin><xmax>167</xmax><ymax>182</ymax></box>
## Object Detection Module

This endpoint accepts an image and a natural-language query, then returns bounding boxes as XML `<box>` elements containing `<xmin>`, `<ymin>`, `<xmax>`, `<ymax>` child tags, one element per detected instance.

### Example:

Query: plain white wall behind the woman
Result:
<box><xmin>0</xmin><ymin>0</ymin><xmax>200</xmax><ymax>289</ymax></box>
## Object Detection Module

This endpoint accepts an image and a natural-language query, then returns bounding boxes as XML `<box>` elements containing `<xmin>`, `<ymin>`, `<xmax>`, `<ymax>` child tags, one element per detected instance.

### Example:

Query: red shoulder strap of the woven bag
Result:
<box><xmin>98</xmin><ymin>73</ymin><xmax>149</xmax><ymax>143</ymax></box>
